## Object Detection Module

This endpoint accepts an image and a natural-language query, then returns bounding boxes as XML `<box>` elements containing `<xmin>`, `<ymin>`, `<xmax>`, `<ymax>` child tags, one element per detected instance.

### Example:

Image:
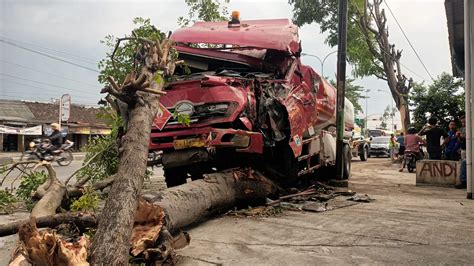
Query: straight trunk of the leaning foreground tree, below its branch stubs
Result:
<box><xmin>91</xmin><ymin>95</ymin><xmax>158</xmax><ymax>265</ymax></box>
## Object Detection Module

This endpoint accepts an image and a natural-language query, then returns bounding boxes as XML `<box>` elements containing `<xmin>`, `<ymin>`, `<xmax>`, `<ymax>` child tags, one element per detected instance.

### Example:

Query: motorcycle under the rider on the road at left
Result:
<box><xmin>20</xmin><ymin>139</ymin><xmax>74</xmax><ymax>166</ymax></box>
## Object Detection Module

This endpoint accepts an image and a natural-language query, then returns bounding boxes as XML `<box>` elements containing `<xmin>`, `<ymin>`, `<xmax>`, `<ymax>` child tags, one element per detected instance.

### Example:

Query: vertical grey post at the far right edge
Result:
<box><xmin>464</xmin><ymin>0</ymin><xmax>474</xmax><ymax>199</ymax></box>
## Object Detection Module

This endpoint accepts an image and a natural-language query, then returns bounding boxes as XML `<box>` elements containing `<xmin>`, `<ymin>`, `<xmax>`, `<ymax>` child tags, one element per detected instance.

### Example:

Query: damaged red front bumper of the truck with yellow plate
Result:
<box><xmin>150</xmin><ymin>127</ymin><xmax>263</xmax><ymax>153</ymax></box>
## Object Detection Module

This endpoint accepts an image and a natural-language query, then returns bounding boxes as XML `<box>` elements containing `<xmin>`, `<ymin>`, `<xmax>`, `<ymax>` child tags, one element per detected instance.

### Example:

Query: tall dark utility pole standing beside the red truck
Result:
<box><xmin>336</xmin><ymin>0</ymin><xmax>347</xmax><ymax>180</ymax></box>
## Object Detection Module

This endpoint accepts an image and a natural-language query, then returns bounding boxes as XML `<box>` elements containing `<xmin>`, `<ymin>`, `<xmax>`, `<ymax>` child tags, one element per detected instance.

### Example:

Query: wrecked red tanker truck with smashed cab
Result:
<box><xmin>150</xmin><ymin>19</ymin><xmax>354</xmax><ymax>186</ymax></box>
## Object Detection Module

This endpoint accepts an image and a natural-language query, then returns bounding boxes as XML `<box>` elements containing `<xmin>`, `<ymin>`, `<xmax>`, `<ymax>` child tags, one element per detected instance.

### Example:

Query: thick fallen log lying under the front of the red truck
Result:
<box><xmin>143</xmin><ymin>169</ymin><xmax>279</xmax><ymax>232</ymax></box>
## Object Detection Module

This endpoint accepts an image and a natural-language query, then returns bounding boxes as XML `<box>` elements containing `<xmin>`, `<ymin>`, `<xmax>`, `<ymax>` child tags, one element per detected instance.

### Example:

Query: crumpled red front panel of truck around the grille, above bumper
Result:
<box><xmin>160</xmin><ymin>76</ymin><xmax>248</xmax><ymax>129</ymax></box>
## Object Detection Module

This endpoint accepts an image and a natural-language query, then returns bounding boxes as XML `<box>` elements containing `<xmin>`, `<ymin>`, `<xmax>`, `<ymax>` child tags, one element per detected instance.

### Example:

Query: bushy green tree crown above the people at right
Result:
<box><xmin>410</xmin><ymin>73</ymin><xmax>464</xmax><ymax>129</ymax></box>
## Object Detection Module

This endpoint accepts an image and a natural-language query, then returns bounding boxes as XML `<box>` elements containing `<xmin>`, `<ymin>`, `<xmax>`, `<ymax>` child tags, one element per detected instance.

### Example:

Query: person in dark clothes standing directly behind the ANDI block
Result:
<box><xmin>418</xmin><ymin>117</ymin><xmax>448</xmax><ymax>160</ymax></box>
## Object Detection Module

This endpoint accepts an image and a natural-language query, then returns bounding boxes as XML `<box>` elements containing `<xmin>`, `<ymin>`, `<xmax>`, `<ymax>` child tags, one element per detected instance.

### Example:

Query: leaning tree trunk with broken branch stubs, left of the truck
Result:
<box><xmin>91</xmin><ymin>37</ymin><xmax>183</xmax><ymax>265</ymax></box>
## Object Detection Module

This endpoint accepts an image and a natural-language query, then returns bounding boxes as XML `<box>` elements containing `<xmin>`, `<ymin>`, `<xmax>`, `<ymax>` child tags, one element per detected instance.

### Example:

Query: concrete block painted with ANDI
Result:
<box><xmin>416</xmin><ymin>160</ymin><xmax>461</xmax><ymax>186</ymax></box>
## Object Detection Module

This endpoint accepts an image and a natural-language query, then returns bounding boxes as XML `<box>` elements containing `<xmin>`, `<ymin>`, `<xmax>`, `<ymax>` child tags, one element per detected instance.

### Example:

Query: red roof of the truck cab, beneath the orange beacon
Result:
<box><xmin>171</xmin><ymin>19</ymin><xmax>300</xmax><ymax>54</ymax></box>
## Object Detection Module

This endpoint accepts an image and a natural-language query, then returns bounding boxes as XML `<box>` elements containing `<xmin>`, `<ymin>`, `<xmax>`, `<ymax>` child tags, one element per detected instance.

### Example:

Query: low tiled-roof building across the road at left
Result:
<box><xmin>0</xmin><ymin>100</ymin><xmax>110</xmax><ymax>151</ymax></box>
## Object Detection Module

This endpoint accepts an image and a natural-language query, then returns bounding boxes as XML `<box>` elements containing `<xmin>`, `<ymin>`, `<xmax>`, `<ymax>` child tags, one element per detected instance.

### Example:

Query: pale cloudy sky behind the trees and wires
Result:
<box><xmin>0</xmin><ymin>0</ymin><xmax>452</xmax><ymax>119</ymax></box>
